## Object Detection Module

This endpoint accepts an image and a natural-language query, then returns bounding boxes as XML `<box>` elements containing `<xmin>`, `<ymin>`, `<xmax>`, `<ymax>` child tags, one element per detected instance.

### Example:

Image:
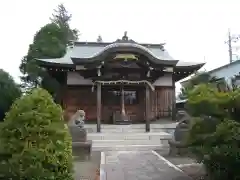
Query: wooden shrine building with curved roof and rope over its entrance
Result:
<box><xmin>38</xmin><ymin>33</ymin><xmax>204</xmax><ymax>132</ymax></box>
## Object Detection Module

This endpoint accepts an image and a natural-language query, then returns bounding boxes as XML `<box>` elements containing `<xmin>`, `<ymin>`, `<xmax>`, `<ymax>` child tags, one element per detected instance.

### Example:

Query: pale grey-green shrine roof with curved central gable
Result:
<box><xmin>35</xmin><ymin>41</ymin><xmax>204</xmax><ymax>69</ymax></box>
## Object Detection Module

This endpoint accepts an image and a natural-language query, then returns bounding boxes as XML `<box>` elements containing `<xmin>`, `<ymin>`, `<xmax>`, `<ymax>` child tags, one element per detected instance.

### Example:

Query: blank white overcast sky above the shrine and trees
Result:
<box><xmin>0</xmin><ymin>0</ymin><xmax>240</xmax><ymax>93</ymax></box>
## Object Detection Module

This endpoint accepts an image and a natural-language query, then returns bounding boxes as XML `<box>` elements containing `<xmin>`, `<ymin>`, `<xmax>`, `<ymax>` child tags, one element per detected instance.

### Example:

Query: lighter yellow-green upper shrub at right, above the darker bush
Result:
<box><xmin>187</xmin><ymin>84</ymin><xmax>240</xmax><ymax>122</ymax></box>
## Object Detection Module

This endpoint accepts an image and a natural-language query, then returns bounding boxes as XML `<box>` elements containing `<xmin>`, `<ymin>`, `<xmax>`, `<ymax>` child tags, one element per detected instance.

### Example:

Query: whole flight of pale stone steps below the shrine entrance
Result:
<box><xmin>85</xmin><ymin>123</ymin><xmax>176</xmax><ymax>151</ymax></box>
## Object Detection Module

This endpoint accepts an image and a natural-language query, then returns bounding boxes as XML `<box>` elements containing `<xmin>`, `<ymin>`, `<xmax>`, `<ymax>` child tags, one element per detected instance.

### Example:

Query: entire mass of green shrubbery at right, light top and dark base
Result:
<box><xmin>187</xmin><ymin>85</ymin><xmax>240</xmax><ymax>180</ymax></box>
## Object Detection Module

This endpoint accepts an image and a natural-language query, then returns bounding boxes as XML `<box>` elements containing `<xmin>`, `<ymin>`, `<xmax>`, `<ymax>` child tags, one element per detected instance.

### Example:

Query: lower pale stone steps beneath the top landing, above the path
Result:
<box><xmin>87</xmin><ymin>132</ymin><xmax>172</xmax><ymax>151</ymax></box>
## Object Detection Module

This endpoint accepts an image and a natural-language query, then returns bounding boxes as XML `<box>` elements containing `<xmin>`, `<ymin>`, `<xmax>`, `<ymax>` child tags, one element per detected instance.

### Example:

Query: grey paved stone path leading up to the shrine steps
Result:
<box><xmin>101</xmin><ymin>151</ymin><xmax>191</xmax><ymax>180</ymax></box>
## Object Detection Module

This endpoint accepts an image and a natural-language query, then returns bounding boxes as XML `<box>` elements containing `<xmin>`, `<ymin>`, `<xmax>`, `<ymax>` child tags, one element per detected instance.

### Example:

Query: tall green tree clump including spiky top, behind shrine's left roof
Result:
<box><xmin>19</xmin><ymin>4</ymin><xmax>78</xmax><ymax>95</ymax></box>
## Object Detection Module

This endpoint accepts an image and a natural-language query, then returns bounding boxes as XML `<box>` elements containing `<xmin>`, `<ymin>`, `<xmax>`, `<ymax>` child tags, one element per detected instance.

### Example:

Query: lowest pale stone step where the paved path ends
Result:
<box><xmin>92</xmin><ymin>144</ymin><xmax>168</xmax><ymax>151</ymax></box>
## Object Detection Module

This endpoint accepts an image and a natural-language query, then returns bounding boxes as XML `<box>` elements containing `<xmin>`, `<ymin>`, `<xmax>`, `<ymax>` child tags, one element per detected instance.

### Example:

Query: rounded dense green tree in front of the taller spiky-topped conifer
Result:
<box><xmin>20</xmin><ymin>23</ymin><xmax>66</xmax><ymax>90</ymax></box>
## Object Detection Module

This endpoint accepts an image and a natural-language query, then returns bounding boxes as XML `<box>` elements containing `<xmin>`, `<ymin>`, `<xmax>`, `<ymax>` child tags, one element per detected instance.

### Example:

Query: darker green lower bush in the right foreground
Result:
<box><xmin>189</xmin><ymin>120</ymin><xmax>240</xmax><ymax>180</ymax></box>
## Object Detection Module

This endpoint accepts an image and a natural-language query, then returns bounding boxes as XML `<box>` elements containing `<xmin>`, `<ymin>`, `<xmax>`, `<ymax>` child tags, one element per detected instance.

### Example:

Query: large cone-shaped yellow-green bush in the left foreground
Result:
<box><xmin>0</xmin><ymin>89</ymin><xmax>73</xmax><ymax>180</ymax></box>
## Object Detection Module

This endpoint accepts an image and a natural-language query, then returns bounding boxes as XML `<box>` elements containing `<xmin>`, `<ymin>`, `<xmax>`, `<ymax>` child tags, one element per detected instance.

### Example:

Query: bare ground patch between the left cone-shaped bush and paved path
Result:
<box><xmin>74</xmin><ymin>151</ymin><xmax>101</xmax><ymax>180</ymax></box>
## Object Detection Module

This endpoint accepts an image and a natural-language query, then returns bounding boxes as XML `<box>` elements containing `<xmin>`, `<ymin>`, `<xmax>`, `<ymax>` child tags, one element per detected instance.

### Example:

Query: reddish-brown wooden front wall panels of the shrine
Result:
<box><xmin>63</xmin><ymin>86</ymin><xmax>173</xmax><ymax>123</ymax></box>
